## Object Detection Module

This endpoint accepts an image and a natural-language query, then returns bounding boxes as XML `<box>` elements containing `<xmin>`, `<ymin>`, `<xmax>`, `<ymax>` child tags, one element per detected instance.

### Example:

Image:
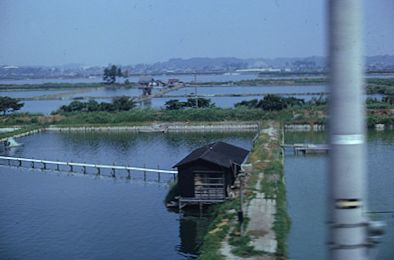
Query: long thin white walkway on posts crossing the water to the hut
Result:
<box><xmin>0</xmin><ymin>156</ymin><xmax>178</xmax><ymax>182</ymax></box>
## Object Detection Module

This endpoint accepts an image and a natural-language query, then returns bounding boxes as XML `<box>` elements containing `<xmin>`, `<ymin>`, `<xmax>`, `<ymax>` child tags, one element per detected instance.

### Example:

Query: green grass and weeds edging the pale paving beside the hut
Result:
<box><xmin>199</xmin><ymin>122</ymin><xmax>290</xmax><ymax>260</ymax></box>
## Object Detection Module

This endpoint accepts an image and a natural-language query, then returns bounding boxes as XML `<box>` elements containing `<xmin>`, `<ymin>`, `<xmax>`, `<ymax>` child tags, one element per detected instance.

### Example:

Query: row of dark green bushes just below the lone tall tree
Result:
<box><xmin>57</xmin><ymin>96</ymin><xmax>136</xmax><ymax>113</ymax></box>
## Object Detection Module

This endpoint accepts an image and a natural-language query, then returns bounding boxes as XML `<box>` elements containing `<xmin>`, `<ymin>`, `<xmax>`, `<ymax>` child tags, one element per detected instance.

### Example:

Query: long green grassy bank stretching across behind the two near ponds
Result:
<box><xmin>0</xmin><ymin>104</ymin><xmax>394</xmax><ymax>128</ymax></box>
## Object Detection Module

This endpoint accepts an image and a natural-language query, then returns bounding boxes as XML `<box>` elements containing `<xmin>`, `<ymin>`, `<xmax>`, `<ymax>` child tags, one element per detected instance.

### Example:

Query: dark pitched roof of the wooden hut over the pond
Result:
<box><xmin>174</xmin><ymin>142</ymin><xmax>249</xmax><ymax>168</ymax></box>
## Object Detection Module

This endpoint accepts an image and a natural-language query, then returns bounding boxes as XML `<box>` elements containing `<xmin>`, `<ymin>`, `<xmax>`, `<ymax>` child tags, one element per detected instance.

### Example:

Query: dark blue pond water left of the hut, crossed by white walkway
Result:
<box><xmin>0</xmin><ymin>133</ymin><xmax>253</xmax><ymax>259</ymax></box>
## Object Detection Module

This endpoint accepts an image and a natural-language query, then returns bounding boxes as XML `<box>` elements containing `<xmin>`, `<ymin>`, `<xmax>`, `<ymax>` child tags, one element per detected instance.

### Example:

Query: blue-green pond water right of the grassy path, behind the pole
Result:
<box><xmin>285</xmin><ymin>131</ymin><xmax>394</xmax><ymax>260</ymax></box>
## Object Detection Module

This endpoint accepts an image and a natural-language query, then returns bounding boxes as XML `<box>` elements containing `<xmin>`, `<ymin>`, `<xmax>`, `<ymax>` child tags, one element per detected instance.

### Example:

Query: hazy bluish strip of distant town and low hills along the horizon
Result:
<box><xmin>0</xmin><ymin>55</ymin><xmax>394</xmax><ymax>79</ymax></box>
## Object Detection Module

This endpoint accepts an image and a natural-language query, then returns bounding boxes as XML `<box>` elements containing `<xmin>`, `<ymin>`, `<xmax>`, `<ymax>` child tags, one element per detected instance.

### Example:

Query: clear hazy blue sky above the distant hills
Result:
<box><xmin>0</xmin><ymin>0</ymin><xmax>394</xmax><ymax>65</ymax></box>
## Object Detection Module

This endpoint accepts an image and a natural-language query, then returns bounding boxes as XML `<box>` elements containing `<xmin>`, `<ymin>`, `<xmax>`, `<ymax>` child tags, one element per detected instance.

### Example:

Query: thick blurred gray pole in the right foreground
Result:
<box><xmin>328</xmin><ymin>0</ymin><xmax>368</xmax><ymax>260</ymax></box>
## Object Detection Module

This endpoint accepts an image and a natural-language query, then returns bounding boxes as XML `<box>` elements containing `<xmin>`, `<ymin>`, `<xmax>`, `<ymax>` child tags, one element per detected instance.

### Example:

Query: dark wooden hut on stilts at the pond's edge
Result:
<box><xmin>174</xmin><ymin>142</ymin><xmax>249</xmax><ymax>207</ymax></box>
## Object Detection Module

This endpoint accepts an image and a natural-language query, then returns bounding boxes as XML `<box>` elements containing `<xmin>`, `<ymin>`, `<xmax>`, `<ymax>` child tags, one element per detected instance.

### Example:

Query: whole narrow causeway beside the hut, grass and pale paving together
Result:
<box><xmin>199</xmin><ymin>122</ymin><xmax>290</xmax><ymax>259</ymax></box>
